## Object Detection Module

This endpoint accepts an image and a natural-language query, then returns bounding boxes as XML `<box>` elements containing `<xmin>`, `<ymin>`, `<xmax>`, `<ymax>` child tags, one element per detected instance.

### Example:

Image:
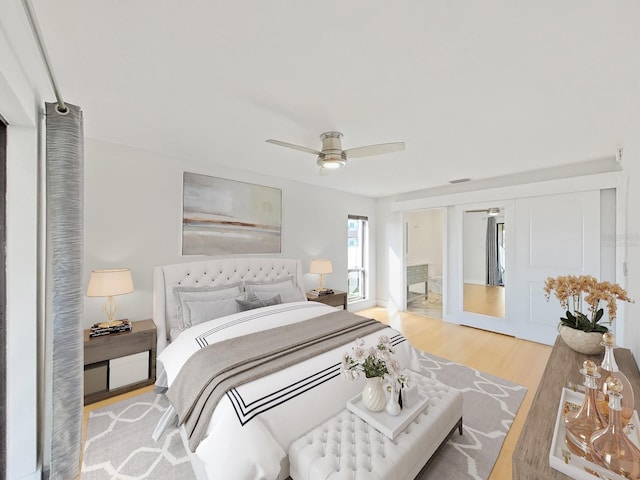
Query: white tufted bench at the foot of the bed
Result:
<box><xmin>289</xmin><ymin>377</ymin><xmax>462</xmax><ymax>480</ymax></box>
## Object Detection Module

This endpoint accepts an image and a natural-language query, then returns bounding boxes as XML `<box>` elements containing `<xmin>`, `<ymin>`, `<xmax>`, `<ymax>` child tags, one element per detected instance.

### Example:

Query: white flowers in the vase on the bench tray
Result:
<box><xmin>341</xmin><ymin>335</ymin><xmax>400</xmax><ymax>381</ymax></box>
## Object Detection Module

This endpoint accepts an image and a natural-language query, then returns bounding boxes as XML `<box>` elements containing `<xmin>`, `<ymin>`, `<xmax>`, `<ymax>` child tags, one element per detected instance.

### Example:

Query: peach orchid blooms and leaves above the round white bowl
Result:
<box><xmin>544</xmin><ymin>275</ymin><xmax>633</xmax><ymax>333</ymax></box>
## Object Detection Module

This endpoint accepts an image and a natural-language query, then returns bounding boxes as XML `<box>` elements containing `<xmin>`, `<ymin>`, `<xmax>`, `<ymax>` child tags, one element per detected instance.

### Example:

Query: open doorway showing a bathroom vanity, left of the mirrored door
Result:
<box><xmin>405</xmin><ymin>209</ymin><xmax>444</xmax><ymax>319</ymax></box>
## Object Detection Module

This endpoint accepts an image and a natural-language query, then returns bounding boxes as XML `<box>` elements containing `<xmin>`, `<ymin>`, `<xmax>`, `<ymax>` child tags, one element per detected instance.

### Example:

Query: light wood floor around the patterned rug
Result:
<box><xmin>83</xmin><ymin>308</ymin><xmax>551</xmax><ymax>480</ymax></box>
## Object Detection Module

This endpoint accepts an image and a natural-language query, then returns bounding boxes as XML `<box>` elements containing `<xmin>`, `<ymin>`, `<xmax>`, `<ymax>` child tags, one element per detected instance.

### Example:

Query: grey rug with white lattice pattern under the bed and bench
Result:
<box><xmin>81</xmin><ymin>354</ymin><xmax>527</xmax><ymax>480</ymax></box>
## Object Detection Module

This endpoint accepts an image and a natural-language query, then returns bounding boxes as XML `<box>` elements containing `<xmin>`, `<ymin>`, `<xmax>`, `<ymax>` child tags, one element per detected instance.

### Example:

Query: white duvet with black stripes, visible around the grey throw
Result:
<box><xmin>158</xmin><ymin>302</ymin><xmax>419</xmax><ymax>480</ymax></box>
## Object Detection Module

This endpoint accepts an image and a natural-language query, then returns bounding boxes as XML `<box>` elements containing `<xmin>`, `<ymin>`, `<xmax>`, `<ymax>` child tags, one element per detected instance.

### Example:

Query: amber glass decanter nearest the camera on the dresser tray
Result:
<box><xmin>591</xmin><ymin>377</ymin><xmax>640</xmax><ymax>480</ymax></box>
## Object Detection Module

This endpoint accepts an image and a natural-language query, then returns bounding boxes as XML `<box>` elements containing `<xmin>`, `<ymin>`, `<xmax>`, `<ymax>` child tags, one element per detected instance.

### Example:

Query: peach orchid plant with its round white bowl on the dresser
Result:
<box><xmin>544</xmin><ymin>275</ymin><xmax>633</xmax><ymax>355</ymax></box>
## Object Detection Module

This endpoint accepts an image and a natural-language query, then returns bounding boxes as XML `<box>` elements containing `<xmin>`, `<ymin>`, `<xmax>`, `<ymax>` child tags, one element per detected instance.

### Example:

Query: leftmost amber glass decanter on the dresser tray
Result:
<box><xmin>564</xmin><ymin>360</ymin><xmax>607</xmax><ymax>460</ymax></box>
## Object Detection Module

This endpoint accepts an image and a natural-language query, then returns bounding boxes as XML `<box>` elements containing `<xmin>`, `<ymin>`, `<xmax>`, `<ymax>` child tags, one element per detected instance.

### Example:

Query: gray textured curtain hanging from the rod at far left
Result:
<box><xmin>46</xmin><ymin>103</ymin><xmax>84</xmax><ymax>480</ymax></box>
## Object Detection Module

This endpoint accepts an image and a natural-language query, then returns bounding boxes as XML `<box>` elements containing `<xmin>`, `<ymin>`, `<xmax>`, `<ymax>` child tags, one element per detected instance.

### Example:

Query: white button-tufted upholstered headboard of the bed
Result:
<box><xmin>153</xmin><ymin>257</ymin><xmax>306</xmax><ymax>353</ymax></box>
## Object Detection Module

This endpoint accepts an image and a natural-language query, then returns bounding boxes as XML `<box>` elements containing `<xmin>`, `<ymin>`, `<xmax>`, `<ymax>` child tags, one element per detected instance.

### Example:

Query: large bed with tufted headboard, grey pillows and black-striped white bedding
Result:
<box><xmin>153</xmin><ymin>257</ymin><xmax>419</xmax><ymax>480</ymax></box>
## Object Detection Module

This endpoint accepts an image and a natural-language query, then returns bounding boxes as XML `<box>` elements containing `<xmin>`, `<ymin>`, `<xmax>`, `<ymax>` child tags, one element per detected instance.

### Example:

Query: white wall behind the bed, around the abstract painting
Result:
<box><xmin>84</xmin><ymin>139</ymin><xmax>376</xmax><ymax>327</ymax></box>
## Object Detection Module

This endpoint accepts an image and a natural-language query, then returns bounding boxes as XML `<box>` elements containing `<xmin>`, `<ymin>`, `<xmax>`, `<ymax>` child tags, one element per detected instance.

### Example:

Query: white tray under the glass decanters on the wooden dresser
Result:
<box><xmin>549</xmin><ymin>388</ymin><xmax>640</xmax><ymax>480</ymax></box>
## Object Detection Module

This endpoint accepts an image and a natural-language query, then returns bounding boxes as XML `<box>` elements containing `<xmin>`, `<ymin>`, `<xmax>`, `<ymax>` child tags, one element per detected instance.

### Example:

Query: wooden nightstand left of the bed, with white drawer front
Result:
<box><xmin>84</xmin><ymin>320</ymin><xmax>156</xmax><ymax>405</ymax></box>
